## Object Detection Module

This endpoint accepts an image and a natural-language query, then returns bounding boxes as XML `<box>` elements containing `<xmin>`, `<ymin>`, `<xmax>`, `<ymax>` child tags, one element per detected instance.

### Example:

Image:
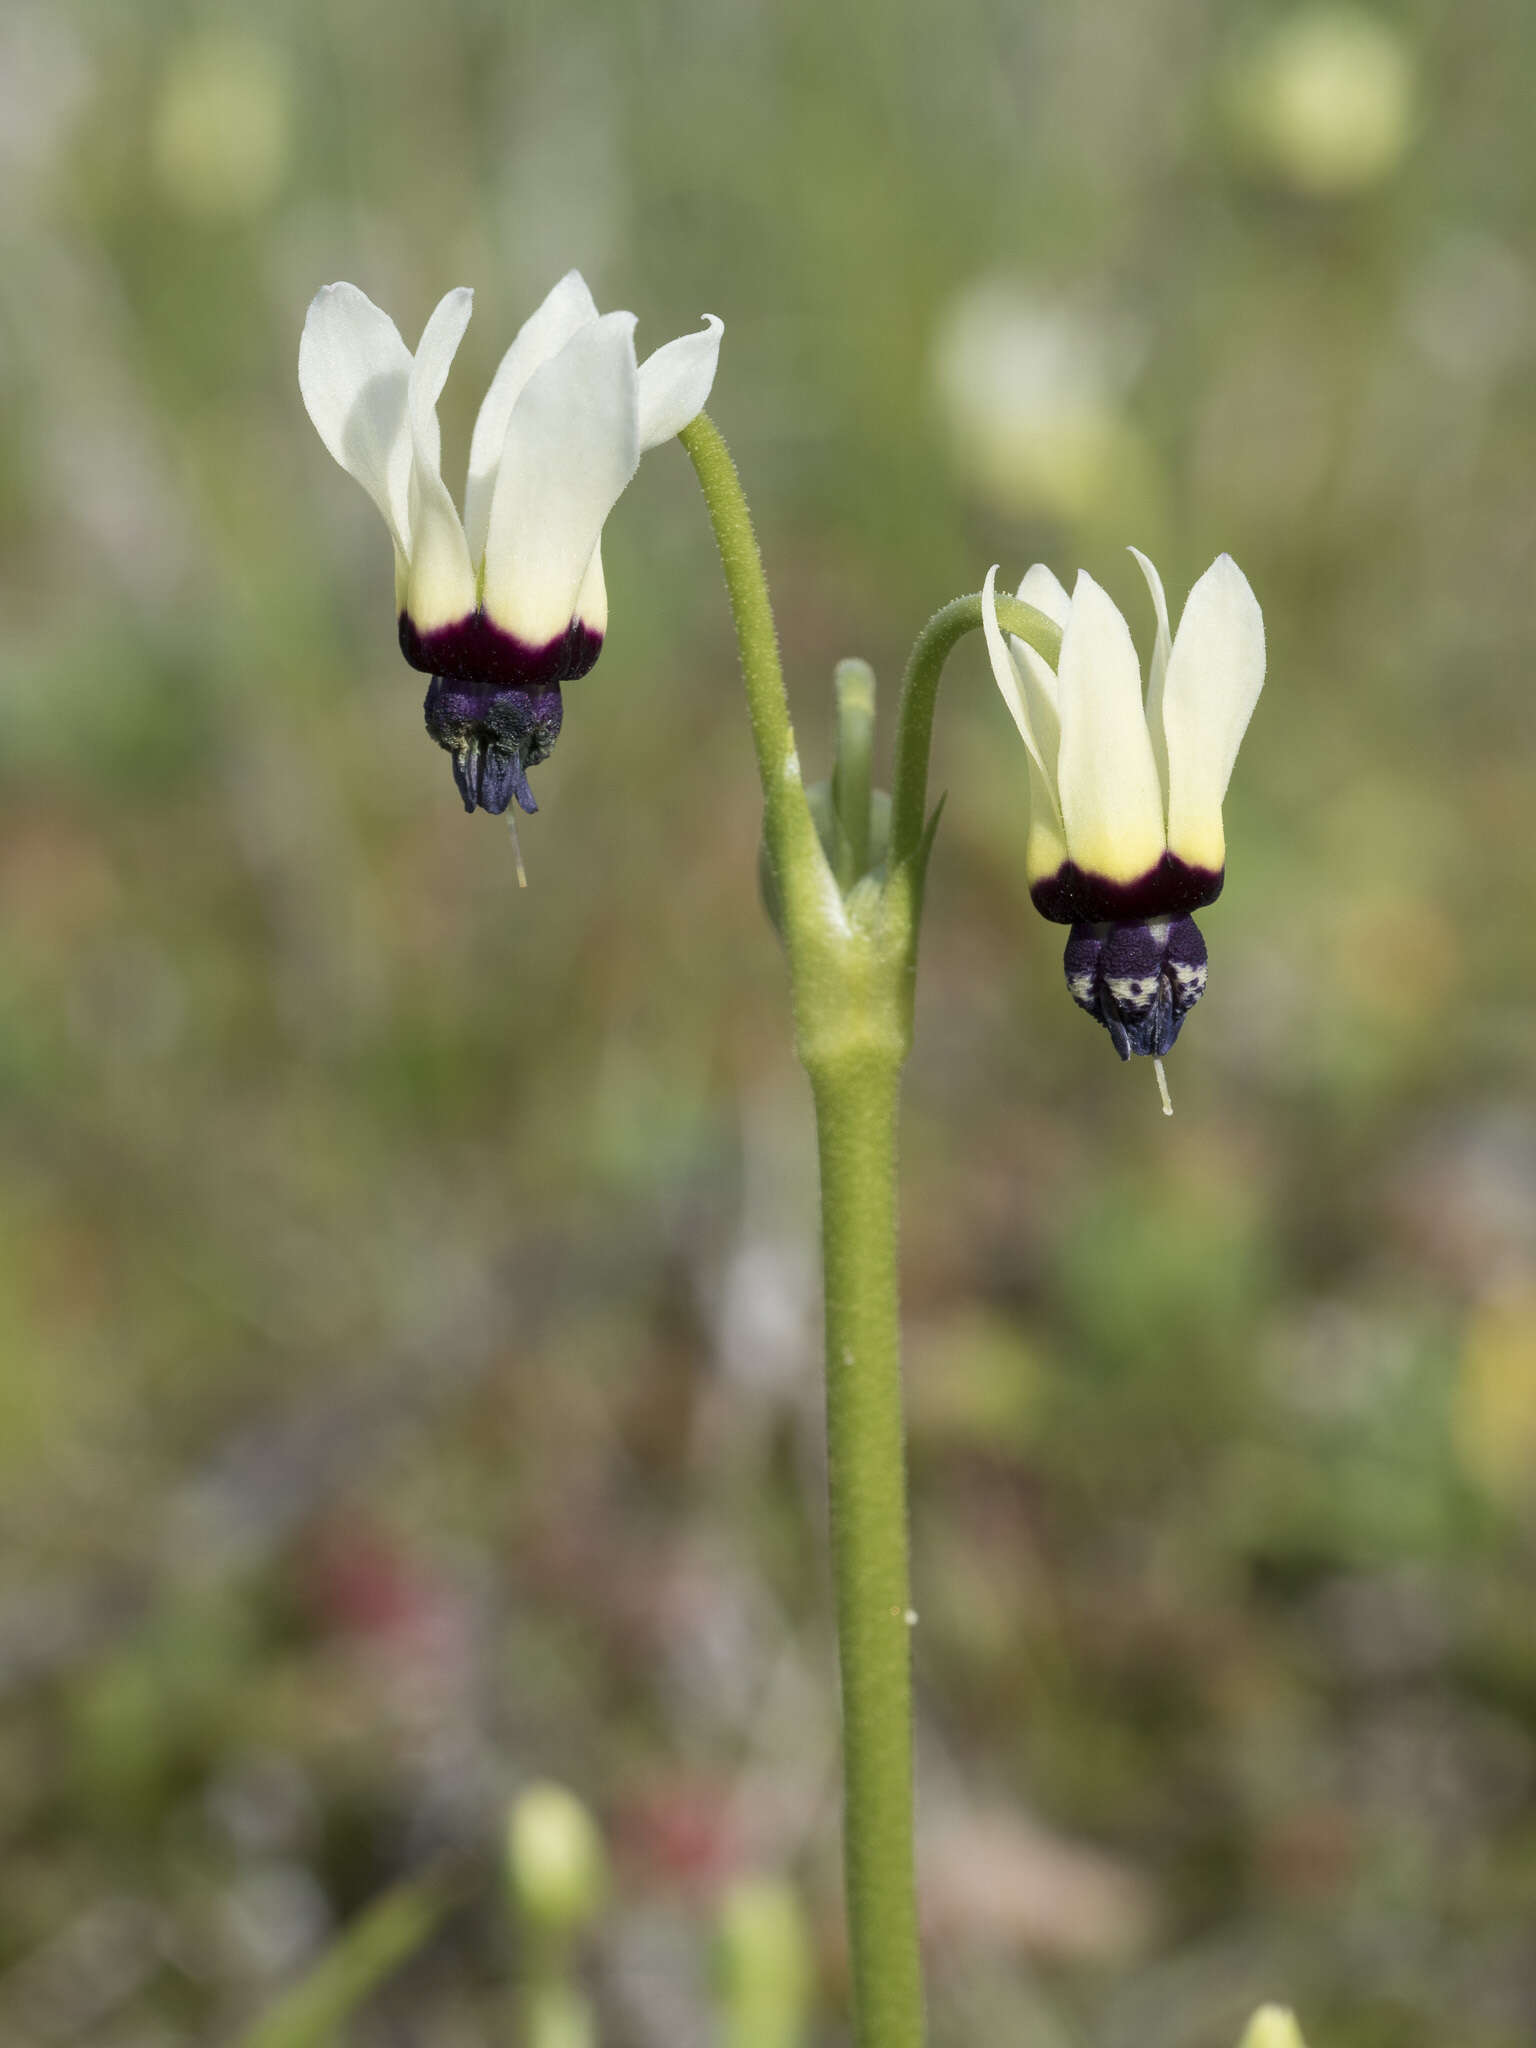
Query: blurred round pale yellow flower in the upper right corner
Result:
<box><xmin>1227</xmin><ymin>6</ymin><xmax>1417</xmax><ymax>199</ymax></box>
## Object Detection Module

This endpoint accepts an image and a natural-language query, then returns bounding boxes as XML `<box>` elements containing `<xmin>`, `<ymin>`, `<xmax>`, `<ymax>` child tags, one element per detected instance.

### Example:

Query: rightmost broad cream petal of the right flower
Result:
<box><xmin>1163</xmin><ymin>555</ymin><xmax>1264</xmax><ymax>868</ymax></box>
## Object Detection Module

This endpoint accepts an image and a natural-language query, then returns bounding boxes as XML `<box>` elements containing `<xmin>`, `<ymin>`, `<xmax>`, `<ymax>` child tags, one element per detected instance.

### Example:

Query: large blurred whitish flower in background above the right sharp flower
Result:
<box><xmin>934</xmin><ymin>276</ymin><xmax>1151</xmax><ymax>520</ymax></box>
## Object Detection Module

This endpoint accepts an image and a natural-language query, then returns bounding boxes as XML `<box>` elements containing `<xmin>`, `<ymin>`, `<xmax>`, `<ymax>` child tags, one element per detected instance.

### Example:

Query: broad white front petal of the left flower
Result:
<box><xmin>485</xmin><ymin>313</ymin><xmax>639</xmax><ymax>645</ymax></box>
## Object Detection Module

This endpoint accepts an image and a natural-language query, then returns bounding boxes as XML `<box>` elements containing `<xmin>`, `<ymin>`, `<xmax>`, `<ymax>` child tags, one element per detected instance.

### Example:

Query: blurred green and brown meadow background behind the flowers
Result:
<box><xmin>0</xmin><ymin>0</ymin><xmax>1536</xmax><ymax>2048</ymax></box>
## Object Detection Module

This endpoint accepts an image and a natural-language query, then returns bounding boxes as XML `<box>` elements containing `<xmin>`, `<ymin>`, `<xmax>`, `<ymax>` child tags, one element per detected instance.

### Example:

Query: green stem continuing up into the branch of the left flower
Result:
<box><xmin>682</xmin><ymin>414</ymin><xmax>924</xmax><ymax>2048</ymax></box>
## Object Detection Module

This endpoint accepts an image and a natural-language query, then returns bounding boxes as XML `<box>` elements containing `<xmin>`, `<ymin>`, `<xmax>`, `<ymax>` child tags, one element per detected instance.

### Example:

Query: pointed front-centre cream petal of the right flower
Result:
<box><xmin>1057</xmin><ymin>569</ymin><xmax>1165</xmax><ymax>883</ymax></box>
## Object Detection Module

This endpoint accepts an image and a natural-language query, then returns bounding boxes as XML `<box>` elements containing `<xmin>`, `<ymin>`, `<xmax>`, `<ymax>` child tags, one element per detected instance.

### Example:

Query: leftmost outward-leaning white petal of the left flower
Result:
<box><xmin>299</xmin><ymin>285</ymin><xmax>412</xmax><ymax>553</ymax></box>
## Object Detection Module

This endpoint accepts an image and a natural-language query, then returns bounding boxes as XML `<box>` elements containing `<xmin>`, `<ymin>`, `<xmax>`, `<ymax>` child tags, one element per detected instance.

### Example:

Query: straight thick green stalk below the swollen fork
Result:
<box><xmin>811</xmin><ymin>1053</ymin><xmax>924</xmax><ymax>2048</ymax></box>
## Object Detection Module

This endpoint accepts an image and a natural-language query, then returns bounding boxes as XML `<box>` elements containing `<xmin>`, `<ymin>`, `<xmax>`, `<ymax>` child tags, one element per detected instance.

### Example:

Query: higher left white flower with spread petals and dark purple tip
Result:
<box><xmin>299</xmin><ymin>270</ymin><xmax>723</xmax><ymax>813</ymax></box>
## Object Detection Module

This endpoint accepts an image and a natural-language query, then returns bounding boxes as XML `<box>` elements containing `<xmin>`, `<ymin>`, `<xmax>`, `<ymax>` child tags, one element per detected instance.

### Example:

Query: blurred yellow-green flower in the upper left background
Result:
<box><xmin>150</xmin><ymin>29</ymin><xmax>293</xmax><ymax>219</ymax></box>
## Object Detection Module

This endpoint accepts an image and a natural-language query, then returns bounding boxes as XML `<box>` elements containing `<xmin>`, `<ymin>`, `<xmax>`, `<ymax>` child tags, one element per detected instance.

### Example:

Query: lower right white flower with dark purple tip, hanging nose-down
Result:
<box><xmin>981</xmin><ymin>549</ymin><xmax>1264</xmax><ymax>1059</ymax></box>
